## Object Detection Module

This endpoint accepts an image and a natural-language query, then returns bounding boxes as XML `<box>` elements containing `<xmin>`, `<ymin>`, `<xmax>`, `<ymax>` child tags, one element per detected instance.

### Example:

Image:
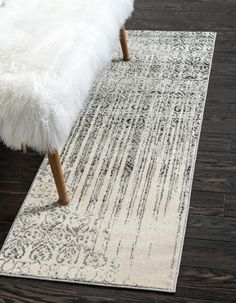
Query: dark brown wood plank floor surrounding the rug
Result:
<box><xmin>0</xmin><ymin>0</ymin><xmax>236</xmax><ymax>303</ymax></box>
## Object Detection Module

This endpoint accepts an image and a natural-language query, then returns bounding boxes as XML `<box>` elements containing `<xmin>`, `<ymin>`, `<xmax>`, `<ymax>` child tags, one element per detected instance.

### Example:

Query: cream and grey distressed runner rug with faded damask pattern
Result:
<box><xmin>0</xmin><ymin>31</ymin><xmax>216</xmax><ymax>292</ymax></box>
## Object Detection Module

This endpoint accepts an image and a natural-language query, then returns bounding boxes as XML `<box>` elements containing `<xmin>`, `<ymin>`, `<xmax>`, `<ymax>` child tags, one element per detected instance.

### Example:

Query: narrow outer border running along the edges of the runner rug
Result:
<box><xmin>0</xmin><ymin>30</ymin><xmax>217</xmax><ymax>293</ymax></box>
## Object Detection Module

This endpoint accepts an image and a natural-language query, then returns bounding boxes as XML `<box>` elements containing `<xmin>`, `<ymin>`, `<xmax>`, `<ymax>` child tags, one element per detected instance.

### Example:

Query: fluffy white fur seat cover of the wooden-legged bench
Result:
<box><xmin>0</xmin><ymin>0</ymin><xmax>133</xmax><ymax>152</ymax></box>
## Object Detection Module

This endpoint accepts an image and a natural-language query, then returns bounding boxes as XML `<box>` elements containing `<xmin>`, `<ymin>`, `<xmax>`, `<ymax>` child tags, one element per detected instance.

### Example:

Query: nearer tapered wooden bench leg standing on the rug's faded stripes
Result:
<box><xmin>48</xmin><ymin>151</ymin><xmax>70</xmax><ymax>205</ymax></box>
